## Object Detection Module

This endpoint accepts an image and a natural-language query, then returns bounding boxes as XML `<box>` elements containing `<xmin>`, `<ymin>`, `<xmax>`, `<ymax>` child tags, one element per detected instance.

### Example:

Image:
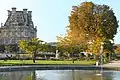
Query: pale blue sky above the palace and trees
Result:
<box><xmin>0</xmin><ymin>0</ymin><xmax>120</xmax><ymax>44</ymax></box>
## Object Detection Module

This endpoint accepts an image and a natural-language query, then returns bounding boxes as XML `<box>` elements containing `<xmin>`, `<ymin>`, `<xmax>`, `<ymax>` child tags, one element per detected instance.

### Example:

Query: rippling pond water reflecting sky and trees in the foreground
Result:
<box><xmin>0</xmin><ymin>70</ymin><xmax>120</xmax><ymax>80</ymax></box>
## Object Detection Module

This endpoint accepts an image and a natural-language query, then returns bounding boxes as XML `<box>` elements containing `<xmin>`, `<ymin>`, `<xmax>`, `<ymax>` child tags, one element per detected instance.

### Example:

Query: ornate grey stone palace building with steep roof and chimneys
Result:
<box><xmin>0</xmin><ymin>8</ymin><xmax>37</xmax><ymax>45</ymax></box>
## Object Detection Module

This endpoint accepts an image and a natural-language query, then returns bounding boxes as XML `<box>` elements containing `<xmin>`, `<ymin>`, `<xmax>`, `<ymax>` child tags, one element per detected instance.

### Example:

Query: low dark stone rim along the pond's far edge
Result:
<box><xmin>0</xmin><ymin>65</ymin><xmax>112</xmax><ymax>72</ymax></box>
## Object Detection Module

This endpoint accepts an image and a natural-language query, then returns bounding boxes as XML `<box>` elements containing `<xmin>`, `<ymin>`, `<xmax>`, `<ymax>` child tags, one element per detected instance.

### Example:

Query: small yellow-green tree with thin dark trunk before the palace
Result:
<box><xmin>19</xmin><ymin>38</ymin><xmax>44</xmax><ymax>63</ymax></box>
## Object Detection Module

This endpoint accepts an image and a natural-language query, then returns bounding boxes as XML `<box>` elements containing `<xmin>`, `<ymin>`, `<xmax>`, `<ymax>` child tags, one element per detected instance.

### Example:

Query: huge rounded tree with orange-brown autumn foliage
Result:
<box><xmin>58</xmin><ymin>2</ymin><xmax>118</xmax><ymax>59</ymax></box>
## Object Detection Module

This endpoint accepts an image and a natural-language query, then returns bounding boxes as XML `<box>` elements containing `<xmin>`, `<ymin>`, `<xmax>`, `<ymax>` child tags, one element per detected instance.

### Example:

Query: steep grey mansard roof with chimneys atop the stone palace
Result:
<box><xmin>4</xmin><ymin>8</ymin><xmax>34</xmax><ymax>27</ymax></box>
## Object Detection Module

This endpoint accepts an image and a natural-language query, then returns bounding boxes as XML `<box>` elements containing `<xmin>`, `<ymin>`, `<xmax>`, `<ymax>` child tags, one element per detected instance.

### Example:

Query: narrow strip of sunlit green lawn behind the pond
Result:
<box><xmin>0</xmin><ymin>60</ymin><xmax>95</xmax><ymax>66</ymax></box>
